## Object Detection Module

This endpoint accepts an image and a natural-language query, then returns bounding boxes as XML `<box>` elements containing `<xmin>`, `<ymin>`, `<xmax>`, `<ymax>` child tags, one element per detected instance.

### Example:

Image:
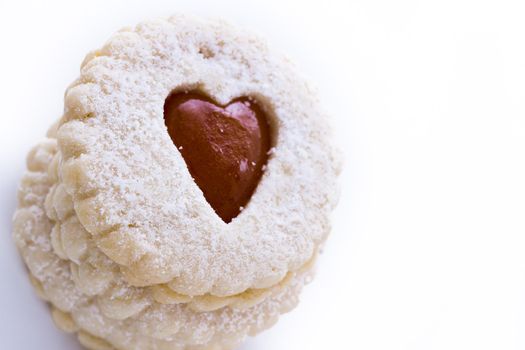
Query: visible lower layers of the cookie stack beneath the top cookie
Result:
<box><xmin>14</xmin><ymin>139</ymin><xmax>311</xmax><ymax>350</ymax></box>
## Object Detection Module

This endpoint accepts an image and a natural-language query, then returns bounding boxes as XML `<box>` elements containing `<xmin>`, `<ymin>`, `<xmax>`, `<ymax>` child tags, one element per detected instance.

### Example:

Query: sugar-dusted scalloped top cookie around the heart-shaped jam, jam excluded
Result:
<box><xmin>57</xmin><ymin>16</ymin><xmax>340</xmax><ymax>296</ymax></box>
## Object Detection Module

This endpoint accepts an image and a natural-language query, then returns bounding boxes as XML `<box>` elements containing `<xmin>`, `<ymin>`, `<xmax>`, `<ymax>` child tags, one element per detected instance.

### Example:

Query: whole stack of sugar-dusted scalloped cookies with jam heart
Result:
<box><xmin>14</xmin><ymin>16</ymin><xmax>340</xmax><ymax>350</ymax></box>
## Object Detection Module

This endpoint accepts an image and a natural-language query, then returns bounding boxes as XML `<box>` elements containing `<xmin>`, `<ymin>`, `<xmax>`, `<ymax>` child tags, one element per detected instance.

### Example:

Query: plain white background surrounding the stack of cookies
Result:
<box><xmin>0</xmin><ymin>0</ymin><xmax>525</xmax><ymax>350</ymax></box>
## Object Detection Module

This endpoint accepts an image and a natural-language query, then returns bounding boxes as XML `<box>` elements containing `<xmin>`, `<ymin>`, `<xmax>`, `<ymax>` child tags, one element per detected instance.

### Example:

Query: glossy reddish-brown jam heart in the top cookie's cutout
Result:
<box><xmin>164</xmin><ymin>92</ymin><xmax>271</xmax><ymax>223</ymax></box>
